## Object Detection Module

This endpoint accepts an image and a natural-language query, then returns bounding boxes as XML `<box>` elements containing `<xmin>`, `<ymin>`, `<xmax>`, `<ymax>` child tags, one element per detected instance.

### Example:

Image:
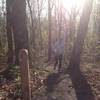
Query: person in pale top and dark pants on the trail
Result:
<box><xmin>53</xmin><ymin>39</ymin><xmax>64</xmax><ymax>72</ymax></box>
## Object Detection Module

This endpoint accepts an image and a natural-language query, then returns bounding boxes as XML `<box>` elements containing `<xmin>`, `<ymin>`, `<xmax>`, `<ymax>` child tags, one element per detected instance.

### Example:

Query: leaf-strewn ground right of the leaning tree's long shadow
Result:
<box><xmin>84</xmin><ymin>67</ymin><xmax>100</xmax><ymax>100</ymax></box>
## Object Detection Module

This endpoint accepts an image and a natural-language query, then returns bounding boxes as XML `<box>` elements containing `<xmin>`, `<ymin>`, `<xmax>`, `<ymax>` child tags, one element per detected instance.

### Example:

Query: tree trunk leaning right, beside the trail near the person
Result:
<box><xmin>69</xmin><ymin>0</ymin><xmax>93</xmax><ymax>73</ymax></box>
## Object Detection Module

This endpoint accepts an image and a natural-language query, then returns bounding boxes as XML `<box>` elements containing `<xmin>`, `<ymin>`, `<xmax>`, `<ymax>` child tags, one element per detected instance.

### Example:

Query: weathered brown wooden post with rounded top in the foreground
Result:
<box><xmin>19</xmin><ymin>49</ymin><xmax>31</xmax><ymax>100</ymax></box>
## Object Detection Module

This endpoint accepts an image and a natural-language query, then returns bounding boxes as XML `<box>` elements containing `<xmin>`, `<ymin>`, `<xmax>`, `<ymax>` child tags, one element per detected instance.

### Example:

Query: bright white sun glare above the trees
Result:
<box><xmin>61</xmin><ymin>0</ymin><xmax>85</xmax><ymax>9</ymax></box>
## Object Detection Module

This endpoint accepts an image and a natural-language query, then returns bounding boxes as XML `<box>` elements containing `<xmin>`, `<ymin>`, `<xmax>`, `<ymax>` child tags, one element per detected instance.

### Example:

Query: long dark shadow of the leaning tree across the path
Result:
<box><xmin>68</xmin><ymin>67</ymin><xmax>95</xmax><ymax>100</ymax></box>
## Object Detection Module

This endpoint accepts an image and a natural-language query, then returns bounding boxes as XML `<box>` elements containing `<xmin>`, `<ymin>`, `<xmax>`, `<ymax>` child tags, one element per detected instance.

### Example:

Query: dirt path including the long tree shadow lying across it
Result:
<box><xmin>32</xmin><ymin>65</ymin><xmax>99</xmax><ymax>100</ymax></box>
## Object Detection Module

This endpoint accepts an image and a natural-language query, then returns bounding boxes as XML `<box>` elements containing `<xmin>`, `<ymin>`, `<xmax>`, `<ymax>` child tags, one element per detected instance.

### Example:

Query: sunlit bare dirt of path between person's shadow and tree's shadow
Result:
<box><xmin>32</xmin><ymin>74</ymin><xmax>77</xmax><ymax>100</ymax></box>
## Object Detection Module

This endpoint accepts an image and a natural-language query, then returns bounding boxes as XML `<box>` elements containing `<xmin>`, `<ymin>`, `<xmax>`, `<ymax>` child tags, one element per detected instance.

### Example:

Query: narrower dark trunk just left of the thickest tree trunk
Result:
<box><xmin>6</xmin><ymin>0</ymin><xmax>14</xmax><ymax>66</ymax></box>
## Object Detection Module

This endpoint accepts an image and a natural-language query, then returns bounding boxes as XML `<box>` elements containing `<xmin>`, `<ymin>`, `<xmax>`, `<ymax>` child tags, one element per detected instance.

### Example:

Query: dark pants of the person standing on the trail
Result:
<box><xmin>54</xmin><ymin>55</ymin><xmax>62</xmax><ymax>72</ymax></box>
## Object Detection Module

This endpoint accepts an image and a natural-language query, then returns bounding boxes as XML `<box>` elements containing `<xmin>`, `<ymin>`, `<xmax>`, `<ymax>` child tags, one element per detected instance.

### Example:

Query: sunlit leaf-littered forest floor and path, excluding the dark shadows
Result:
<box><xmin>0</xmin><ymin>61</ymin><xmax>100</xmax><ymax>100</ymax></box>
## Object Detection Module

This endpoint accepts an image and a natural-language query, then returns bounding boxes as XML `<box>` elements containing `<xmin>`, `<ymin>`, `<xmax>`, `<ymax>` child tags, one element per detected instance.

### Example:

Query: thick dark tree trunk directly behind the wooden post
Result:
<box><xmin>13</xmin><ymin>0</ymin><xmax>29</xmax><ymax>65</ymax></box>
